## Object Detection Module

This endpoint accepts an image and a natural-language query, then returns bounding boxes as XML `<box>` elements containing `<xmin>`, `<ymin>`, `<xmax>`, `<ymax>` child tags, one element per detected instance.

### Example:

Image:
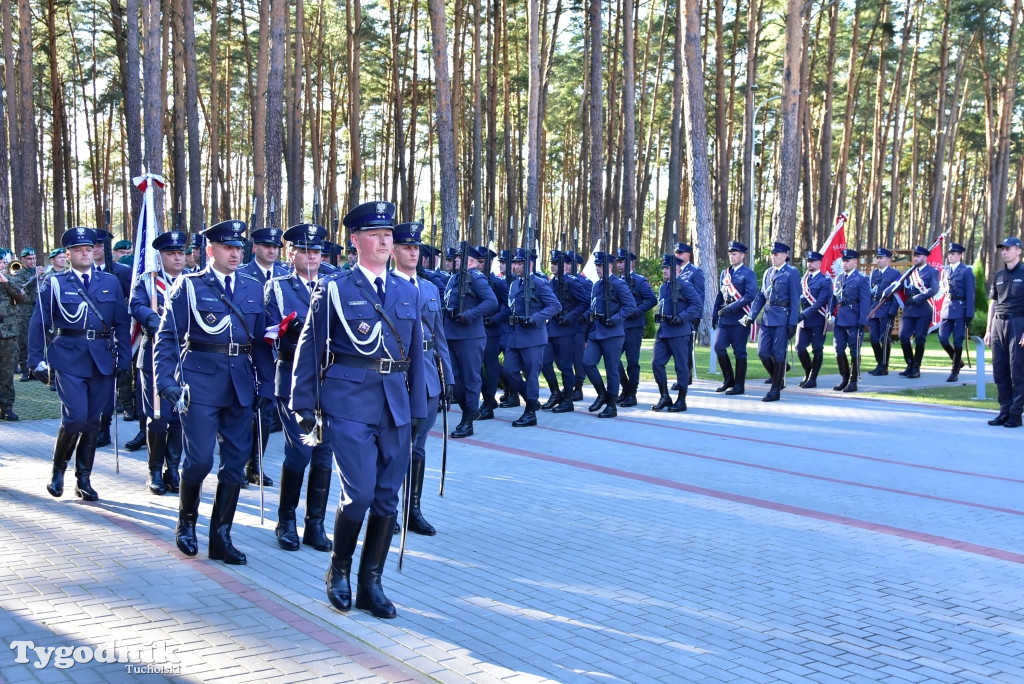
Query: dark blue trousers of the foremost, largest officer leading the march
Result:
<box><xmin>324</xmin><ymin>407</ymin><xmax>413</xmax><ymax>521</ymax></box>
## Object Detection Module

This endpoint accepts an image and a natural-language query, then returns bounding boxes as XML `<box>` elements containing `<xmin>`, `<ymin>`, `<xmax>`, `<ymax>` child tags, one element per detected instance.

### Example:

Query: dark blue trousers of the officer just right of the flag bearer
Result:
<box><xmin>181</xmin><ymin>397</ymin><xmax>253</xmax><ymax>485</ymax></box>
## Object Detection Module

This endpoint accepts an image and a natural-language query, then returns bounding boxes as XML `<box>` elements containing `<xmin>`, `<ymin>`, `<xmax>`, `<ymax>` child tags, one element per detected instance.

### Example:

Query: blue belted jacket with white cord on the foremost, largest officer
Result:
<box><xmin>291</xmin><ymin>268</ymin><xmax>427</xmax><ymax>423</ymax></box>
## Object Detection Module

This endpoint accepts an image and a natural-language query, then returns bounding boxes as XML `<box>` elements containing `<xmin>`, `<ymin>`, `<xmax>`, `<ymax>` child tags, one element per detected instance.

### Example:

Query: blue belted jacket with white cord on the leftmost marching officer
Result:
<box><xmin>29</xmin><ymin>268</ymin><xmax>131</xmax><ymax>378</ymax></box>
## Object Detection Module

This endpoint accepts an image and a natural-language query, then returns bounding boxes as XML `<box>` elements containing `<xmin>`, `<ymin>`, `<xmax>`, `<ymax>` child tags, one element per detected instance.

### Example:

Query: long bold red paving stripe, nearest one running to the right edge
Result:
<box><xmin>442</xmin><ymin>437</ymin><xmax>1024</xmax><ymax>565</ymax></box>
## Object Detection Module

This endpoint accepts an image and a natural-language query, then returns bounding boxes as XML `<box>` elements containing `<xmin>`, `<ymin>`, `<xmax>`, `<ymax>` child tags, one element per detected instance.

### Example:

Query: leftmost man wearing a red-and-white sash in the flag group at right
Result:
<box><xmin>712</xmin><ymin>241</ymin><xmax>758</xmax><ymax>394</ymax></box>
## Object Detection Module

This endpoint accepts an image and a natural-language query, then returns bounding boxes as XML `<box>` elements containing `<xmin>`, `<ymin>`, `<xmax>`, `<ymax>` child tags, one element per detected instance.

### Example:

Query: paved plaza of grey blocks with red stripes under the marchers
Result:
<box><xmin>0</xmin><ymin>371</ymin><xmax>1024</xmax><ymax>684</ymax></box>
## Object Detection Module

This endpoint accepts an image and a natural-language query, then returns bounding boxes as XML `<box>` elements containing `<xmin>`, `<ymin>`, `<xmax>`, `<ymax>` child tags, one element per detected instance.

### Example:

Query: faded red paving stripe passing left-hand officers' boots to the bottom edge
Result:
<box><xmin>84</xmin><ymin>505</ymin><xmax>419</xmax><ymax>682</ymax></box>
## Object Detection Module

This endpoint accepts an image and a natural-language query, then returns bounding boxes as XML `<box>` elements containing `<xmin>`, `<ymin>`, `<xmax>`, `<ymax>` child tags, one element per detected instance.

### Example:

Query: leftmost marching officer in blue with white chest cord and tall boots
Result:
<box><xmin>29</xmin><ymin>226</ymin><xmax>131</xmax><ymax>501</ymax></box>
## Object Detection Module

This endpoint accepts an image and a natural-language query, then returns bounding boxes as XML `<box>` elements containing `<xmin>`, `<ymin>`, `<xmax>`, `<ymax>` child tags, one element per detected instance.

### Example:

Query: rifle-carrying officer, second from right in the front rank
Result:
<box><xmin>583</xmin><ymin>252</ymin><xmax>637</xmax><ymax>418</ymax></box>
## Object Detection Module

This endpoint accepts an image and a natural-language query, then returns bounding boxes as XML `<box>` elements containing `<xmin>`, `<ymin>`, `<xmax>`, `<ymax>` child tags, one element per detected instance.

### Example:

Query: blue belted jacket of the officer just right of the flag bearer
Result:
<box><xmin>157</xmin><ymin>264</ymin><xmax>273</xmax><ymax>407</ymax></box>
